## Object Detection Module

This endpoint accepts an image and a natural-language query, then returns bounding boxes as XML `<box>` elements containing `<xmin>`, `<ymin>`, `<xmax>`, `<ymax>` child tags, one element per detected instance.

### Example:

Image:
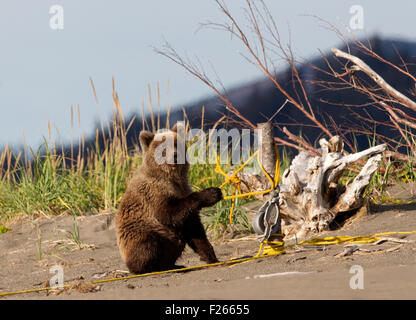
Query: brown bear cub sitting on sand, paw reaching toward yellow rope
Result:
<box><xmin>116</xmin><ymin>126</ymin><xmax>222</xmax><ymax>273</ymax></box>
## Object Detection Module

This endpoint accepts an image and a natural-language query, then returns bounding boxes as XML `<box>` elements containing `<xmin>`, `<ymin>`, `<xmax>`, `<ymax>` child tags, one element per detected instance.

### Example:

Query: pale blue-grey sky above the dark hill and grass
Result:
<box><xmin>0</xmin><ymin>0</ymin><xmax>416</xmax><ymax>147</ymax></box>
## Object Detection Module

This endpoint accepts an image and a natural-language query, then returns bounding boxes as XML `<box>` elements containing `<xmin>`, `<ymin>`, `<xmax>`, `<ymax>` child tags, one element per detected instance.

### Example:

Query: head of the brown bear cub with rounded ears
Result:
<box><xmin>139</xmin><ymin>123</ymin><xmax>189</xmax><ymax>175</ymax></box>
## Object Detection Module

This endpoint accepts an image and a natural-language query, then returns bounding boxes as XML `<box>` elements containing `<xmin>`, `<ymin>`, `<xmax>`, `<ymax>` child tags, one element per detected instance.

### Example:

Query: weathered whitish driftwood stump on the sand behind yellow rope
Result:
<box><xmin>240</xmin><ymin>136</ymin><xmax>386</xmax><ymax>240</ymax></box>
